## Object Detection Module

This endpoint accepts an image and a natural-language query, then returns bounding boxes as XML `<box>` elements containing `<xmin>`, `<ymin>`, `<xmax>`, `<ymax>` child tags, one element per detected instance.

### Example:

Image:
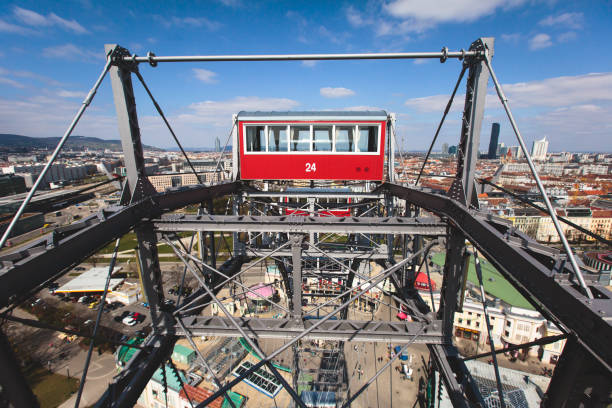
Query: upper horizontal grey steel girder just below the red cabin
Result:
<box><xmin>153</xmin><ymin>214</ymin><xmax>446</xmax><ymax>236</ymax></box>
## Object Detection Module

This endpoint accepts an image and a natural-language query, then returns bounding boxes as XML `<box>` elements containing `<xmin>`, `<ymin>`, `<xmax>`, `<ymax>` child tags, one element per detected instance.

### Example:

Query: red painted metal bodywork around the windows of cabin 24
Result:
<box><xmin>238</xmin><ymin>121</ymin><xmax>386</xmax><ymax>181</ymax></box>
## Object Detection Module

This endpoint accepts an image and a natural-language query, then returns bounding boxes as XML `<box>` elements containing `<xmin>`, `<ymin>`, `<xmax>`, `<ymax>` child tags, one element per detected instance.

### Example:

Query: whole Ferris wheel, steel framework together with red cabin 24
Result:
<box><xmin>0</xmin><ymin>38</ymin><xmax>612</xmax><ymax>407</ymax></box>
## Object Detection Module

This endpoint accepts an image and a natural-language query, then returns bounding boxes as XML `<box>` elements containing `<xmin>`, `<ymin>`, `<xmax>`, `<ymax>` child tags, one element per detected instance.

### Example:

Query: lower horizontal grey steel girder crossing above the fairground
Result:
<box><xmin>175</xmin><ymin>316</ymin><xmax>446</xmax><ymax>344</ymax></box>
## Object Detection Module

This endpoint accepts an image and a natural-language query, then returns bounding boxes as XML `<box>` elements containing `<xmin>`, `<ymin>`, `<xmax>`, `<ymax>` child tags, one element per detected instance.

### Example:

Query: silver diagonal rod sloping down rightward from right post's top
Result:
<box><xmin>484</xmin><ymin>55</ymin><xmax>593</xmax><ymax>299</ymax></box>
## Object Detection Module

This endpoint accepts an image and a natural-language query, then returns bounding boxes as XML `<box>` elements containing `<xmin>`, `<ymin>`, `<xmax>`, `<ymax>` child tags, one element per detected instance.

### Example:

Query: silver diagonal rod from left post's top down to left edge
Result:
<box><xmin>0</xmin><ymin>56</ymin><xmax>111</xmax><ymax>248</ymax></box>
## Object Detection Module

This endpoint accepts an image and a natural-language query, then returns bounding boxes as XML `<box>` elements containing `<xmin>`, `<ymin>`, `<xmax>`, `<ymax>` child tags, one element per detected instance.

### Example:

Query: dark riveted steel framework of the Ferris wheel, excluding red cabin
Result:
<box><xmin>0</xmin><ymin>39</ymin><xmax>612</xmax><ymax>407</ymax></box>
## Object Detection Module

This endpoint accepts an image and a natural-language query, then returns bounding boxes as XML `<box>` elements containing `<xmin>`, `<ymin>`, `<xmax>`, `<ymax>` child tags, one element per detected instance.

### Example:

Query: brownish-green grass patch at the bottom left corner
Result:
<box><xmin>25</xmin><ymin>366</ymin><xmax>79</xmax><ymax>408</ymax></box>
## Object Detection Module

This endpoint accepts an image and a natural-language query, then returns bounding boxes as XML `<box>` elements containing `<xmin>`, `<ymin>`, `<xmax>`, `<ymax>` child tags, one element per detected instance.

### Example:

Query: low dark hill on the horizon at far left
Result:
<box><xmin>0</xmin><ymin>133</ymin><xmax>163</xmax><ymax>152</ymax></box>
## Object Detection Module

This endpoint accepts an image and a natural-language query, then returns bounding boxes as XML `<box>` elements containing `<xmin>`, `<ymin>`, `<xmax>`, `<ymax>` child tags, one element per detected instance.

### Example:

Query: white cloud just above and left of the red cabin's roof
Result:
<box><xmin>177</xmin><ymin>96</ymin><xmax>299</xmax><ymax>127</ymax></box>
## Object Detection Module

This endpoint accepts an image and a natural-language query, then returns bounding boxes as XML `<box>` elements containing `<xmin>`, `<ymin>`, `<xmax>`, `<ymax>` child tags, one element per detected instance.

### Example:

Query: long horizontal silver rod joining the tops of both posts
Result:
<box><xmin>123</xmin><ymin>49</ymin><xmax>482</xmax><ymax>65</ymax></box>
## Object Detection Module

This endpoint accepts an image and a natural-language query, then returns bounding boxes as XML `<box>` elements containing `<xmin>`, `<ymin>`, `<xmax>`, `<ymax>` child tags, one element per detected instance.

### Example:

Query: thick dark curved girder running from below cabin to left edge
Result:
<box><xmin>0</xmin><ymin>182</ymin><xmax>240</xmax><ymax>307</ymax></box>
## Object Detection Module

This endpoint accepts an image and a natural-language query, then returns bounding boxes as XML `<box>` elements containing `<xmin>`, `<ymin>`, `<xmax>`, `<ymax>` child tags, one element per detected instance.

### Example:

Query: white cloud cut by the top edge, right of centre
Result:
<box><xmin>383</xmin><ymin>0</ymin><xmax>525</xmax><ymax>24</ymax></box>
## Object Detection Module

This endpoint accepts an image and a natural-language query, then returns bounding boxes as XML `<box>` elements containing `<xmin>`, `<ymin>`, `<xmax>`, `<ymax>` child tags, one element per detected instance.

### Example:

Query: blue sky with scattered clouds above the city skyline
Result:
<box><xmin>0</xmin><ymin>0</ymin><xmax>612</xmax><ymax>151</ymax></box>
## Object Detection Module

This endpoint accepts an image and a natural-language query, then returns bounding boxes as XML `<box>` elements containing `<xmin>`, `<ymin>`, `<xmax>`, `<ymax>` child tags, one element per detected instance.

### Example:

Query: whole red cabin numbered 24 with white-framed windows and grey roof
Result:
<box><xmin>234</xmin><ymin>111</ymin><xmax>388</xmax><ymax>181</ymax></box>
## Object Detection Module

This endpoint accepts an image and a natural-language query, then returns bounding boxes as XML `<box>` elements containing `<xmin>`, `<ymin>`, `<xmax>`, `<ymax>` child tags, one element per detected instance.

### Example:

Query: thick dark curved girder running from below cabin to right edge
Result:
<box><xmin>381</xmin><ymin>184</ymin><xmax>612</xmax><ymax>370</ymax></box>
